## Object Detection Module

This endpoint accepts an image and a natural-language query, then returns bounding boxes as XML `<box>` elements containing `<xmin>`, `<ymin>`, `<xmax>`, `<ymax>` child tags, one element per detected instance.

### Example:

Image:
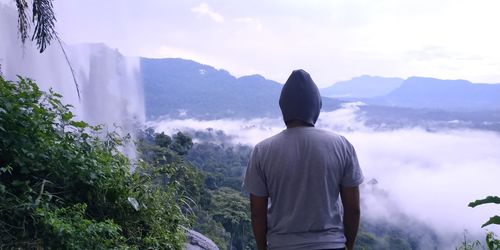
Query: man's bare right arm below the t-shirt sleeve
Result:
<box><xmin>340</xmin><ymin>186</ymin><xmax>361</xmax><ymax>250</ymax></box>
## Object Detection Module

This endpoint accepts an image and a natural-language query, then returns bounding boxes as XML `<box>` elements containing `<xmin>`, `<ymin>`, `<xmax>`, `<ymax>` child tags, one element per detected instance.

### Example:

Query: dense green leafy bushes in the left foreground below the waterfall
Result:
<box><xmin>0</xmin><ymin>78</ymin><xmax>189</xmax><ymax>249</ymax></box>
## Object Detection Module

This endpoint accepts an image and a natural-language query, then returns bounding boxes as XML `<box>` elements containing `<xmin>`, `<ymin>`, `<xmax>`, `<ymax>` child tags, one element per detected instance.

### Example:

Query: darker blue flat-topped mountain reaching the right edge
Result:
<box><xmin>376</xmin><ymin>77</ymin><xmax>500</xmax><ymax>111</ymax></box>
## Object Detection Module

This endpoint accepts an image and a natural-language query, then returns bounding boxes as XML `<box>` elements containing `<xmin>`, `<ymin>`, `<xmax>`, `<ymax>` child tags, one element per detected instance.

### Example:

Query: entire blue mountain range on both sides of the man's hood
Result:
<box><xmin>141</xmin><ymin>58</ymin><xmax>500</xmax><ymax>131</ymax></box>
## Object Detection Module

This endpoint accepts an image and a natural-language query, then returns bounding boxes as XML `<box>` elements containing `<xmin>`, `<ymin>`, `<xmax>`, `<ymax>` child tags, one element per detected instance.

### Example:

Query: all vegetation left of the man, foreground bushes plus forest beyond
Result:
<box><xmin>0</xmin><ymin>73</ymin><xmax>253</xmax><ymax>249</ymax></box>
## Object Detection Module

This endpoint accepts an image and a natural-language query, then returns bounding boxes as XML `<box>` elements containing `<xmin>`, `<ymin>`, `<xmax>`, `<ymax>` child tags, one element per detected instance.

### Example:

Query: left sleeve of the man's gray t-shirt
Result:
<box><xmin>243</xmin><ymin>147</ymin><xmax>269</xmax><ymax>197</ymax></box>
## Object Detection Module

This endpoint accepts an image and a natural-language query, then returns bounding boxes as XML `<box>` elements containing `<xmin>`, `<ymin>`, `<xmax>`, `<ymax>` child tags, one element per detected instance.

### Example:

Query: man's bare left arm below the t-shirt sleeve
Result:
<box><xmin>250</xmin><ymin>194</ymin><xmax>267</xmax><ymax>250</ymax></box>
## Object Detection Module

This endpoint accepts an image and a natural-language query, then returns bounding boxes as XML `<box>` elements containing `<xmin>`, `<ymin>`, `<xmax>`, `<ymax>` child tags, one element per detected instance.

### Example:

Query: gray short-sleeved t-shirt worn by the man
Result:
<box><xmin>243</xmin><ymin>127</ymin><xmax>363</xmax><ymax>250</ymax></box>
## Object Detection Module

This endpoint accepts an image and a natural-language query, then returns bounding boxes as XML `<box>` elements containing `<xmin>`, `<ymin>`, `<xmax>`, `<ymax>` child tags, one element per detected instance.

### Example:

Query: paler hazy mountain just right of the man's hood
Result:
<box><xmin>320</xmin><ymin>75</ymin><xmax>404</xmax><ymax>99</ymax></box>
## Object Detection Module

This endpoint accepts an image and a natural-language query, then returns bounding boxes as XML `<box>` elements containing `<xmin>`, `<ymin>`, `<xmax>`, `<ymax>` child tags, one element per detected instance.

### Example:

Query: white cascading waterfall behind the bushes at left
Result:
<box><xmin>0</xmin><ymin>4</ymin><xmax>145</xmax><ymax>162</ymax></box>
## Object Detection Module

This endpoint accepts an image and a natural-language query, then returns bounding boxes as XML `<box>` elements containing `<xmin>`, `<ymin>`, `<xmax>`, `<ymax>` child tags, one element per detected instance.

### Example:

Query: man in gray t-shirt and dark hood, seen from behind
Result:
<box><xmin>243</xmin><ymin>70</ymin><xmax>363</xmax><ymax>250</ymax></box>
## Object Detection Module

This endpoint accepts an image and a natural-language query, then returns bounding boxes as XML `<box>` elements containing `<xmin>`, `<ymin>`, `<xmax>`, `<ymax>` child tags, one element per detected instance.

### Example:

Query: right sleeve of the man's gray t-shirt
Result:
<box><xmin>341</xmin><ymin>138</ymin><xmax>364</xmax><ymax>187</ymax></box>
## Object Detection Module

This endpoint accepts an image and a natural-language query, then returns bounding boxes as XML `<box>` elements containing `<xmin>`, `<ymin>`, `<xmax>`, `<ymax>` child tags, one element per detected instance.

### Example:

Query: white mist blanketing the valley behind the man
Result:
<box><xmin>147</xmin><ymin>103</ymin><xmax>500</xmax><ymax>248</ymax></box>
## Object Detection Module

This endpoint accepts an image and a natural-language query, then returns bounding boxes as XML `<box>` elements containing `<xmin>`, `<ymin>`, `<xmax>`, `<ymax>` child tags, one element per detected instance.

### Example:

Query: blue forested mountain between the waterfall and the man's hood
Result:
<box><xmin>141</xmin><ymin>58</ymin><xmax>340</xmax><ymax>119</ymax></box>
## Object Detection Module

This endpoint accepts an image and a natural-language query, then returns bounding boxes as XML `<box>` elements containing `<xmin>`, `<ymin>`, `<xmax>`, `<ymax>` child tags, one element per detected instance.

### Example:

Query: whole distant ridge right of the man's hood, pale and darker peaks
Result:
<box><xmin>321</xmin><ymin>76</ymin><xmax>500</xmax><ymax>112</ymax></box>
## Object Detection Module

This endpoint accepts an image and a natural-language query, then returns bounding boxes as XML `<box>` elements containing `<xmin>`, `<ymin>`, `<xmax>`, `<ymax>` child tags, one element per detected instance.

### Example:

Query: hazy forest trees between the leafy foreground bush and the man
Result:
<box><xmin>186</xmin><ymin>133</ymin><xmax>255</xmax><ymax>250</ymax></box>
